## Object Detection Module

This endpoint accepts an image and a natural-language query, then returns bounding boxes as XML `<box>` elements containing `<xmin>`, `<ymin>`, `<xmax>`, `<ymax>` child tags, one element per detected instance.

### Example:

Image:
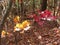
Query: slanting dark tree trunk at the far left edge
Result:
<box><xmin>0</xmin><ymin>0</ymin><xmax>12</xmax><ymax>44</ymax></box>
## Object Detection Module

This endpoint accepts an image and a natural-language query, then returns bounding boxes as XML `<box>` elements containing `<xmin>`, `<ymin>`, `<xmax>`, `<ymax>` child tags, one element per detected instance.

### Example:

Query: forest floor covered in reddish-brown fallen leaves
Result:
<box><xmin>1</xmin><ymin>21</ymin><xmax>60</xmax><ymax>45</ymax></box>
